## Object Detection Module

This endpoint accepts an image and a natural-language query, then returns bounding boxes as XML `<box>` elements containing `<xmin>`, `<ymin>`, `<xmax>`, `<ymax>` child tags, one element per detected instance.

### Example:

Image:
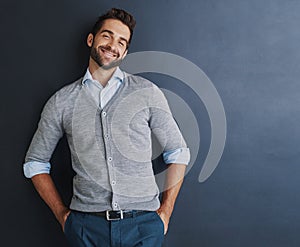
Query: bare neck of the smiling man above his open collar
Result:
<box><xmin>89</xmin><ymin>58</ymin><xmax>117</xmax><ymax>87</ymax></box>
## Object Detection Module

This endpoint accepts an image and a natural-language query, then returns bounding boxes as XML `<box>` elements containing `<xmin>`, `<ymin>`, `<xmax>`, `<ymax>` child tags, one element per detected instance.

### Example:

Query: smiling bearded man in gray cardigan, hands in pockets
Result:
<box><xmin>24</xmin><ymin>9</ymin><xmax>189</xmax><ymax>247</ymax></box>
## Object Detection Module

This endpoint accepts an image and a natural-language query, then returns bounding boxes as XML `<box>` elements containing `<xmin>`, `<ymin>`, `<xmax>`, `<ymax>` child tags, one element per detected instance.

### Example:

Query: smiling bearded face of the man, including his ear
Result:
<box><xmin>87</xmin><ymin>19</ymin><xmax>130</xmax><ymax>69</ymax></box>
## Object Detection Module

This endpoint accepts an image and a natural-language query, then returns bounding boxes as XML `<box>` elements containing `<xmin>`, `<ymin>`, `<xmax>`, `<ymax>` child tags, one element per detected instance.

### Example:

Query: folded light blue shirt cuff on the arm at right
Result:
<box><xmin>163</xmin><ymin>148</ymin><xmax>191</xmax><ymax>165</ymax></box>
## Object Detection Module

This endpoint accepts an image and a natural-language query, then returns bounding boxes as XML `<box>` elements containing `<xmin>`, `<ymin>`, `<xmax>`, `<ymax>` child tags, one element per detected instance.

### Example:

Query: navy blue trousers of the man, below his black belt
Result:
<box><xmin>65</xmin><ymin>211</ymin><xmax>164</xmax><ymax>247</ymax></box>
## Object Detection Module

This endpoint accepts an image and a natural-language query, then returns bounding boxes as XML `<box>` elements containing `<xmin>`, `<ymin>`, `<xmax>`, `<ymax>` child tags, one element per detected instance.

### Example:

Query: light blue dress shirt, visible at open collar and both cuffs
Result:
<box><xmin>23</xmin><ymin>67</ymin><xmax>190</xmax><ymax>178</ymax></box>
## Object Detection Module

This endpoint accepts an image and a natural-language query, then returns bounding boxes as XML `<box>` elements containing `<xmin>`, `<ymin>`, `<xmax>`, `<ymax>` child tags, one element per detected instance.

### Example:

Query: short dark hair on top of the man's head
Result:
<box><xmin>92</xmin><ymin>8</ymin><xmax>136</xmax><ymax>44</ymax></box>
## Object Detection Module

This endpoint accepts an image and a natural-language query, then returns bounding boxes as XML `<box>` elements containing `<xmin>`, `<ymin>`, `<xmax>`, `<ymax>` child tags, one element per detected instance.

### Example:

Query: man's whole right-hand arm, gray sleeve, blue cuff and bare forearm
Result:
<box><xmin>149</xmin><ymin>86</ymin><xmax>190</xmax><ymax>234</ymax></box>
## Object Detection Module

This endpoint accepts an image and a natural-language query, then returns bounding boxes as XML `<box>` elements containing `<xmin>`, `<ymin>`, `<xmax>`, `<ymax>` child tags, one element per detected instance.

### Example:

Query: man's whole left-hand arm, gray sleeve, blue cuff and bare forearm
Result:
<box><xmin>24</xmin><ymin>92</ymin><xmax>70</xmax><ymax>228</ymax></box>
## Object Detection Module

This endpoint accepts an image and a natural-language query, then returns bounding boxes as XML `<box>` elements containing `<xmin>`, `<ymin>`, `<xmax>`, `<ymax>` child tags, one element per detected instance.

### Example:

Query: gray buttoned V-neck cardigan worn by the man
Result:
<box><xmin>25</xmin><ymin>74</ymin><xmax>189</xmax><ymax>212</ymax></box>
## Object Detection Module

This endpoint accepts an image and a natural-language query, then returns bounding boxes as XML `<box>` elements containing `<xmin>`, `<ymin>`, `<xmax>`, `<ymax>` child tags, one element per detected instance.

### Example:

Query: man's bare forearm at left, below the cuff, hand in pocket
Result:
<box><xmin>31</xmin><ymin>174</ymin><xmax>70</xmax><ymax>230</ymax></box>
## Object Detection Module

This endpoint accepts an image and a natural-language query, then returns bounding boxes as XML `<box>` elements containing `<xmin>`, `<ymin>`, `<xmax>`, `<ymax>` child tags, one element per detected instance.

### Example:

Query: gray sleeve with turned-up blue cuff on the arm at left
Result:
<box><xmin>23</xmin><ymin>95</ymin><xmax>63</xmax><ymax>178</ymax></box>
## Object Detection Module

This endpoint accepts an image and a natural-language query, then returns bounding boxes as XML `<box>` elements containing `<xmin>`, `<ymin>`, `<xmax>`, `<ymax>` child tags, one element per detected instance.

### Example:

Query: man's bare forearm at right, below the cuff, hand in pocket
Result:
<box><xmin>157</xmin><ymin>164</ymin><xmax>186</xmax><ymax>234</ymax></box>
